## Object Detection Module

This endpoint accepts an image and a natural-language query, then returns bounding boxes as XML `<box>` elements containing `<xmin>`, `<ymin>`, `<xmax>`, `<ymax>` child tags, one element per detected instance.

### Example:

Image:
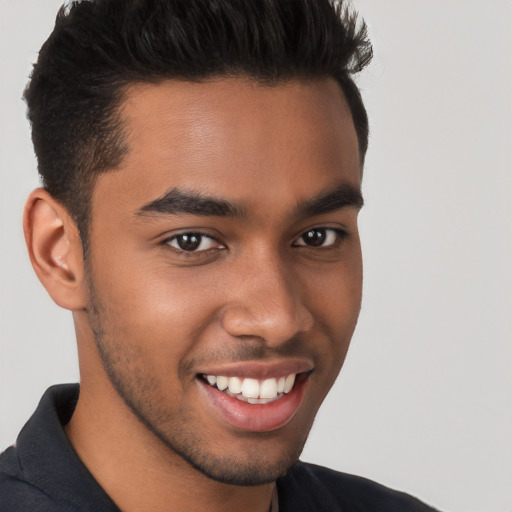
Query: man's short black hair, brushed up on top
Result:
<box><xmin>24</xmin><ymin>0</ymin><xmax>372</xmax><ymax>248</ymax></box>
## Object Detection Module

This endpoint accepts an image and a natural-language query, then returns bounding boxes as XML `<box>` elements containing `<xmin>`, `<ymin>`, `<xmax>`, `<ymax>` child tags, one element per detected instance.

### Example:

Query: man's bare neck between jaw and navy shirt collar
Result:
<box><xmin>65</xmin><ymin>376</ymin><xmax>275</xmax><ymax>512</ymax></box>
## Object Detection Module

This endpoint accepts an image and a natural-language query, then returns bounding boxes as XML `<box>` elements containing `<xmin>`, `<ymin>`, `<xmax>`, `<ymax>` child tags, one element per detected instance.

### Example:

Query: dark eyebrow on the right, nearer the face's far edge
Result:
<box><xmin>295</xmin><ymin>183</ymin><xmax>364</xmax><ymax>217</ymax></box>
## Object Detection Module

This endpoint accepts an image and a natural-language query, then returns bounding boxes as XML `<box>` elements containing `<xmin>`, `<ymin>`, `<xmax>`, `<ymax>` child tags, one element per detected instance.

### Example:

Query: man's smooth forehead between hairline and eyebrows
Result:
<box><xmin>93</xmin><ymin>79</ymin><xmax>360</xmax><ymax>217</ymax></box>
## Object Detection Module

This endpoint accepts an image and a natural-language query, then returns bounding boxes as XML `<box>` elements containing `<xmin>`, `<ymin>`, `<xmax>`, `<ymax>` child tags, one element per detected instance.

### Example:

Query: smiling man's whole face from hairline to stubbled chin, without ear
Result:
<box><xmin>84</xmin><ymin>79</ymin><xmax>362</xmax><ymax>484</ymax></box>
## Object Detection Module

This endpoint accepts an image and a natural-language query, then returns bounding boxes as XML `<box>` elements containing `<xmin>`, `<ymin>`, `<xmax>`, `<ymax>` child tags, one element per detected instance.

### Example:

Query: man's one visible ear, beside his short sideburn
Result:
<box><xmin>23</xmin><ymin>188</ymin><xmax>87</xmax><ymax>311</ymax></box>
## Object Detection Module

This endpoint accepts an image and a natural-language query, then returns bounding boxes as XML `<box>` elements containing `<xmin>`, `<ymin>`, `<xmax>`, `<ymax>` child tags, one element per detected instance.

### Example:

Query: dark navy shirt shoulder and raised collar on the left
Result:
<box><xmin>0</xmin><ymin>385</ymin><xmax>118</xmax><ymax>512</ymax></box>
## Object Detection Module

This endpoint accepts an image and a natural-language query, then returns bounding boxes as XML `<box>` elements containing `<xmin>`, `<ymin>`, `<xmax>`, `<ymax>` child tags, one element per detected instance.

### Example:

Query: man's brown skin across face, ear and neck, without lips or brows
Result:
<box><xmin>25</xmin><ymin>79</ymin><xmax>362</xmax><ymax>511</ymax></box>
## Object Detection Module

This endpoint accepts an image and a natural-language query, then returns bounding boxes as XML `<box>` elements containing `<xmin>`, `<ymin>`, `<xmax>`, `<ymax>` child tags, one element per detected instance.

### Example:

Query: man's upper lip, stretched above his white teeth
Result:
<box><xmin>198</xmin><ymin>358</ymin><xmax>314</xmax><ymax>379</ymax></box>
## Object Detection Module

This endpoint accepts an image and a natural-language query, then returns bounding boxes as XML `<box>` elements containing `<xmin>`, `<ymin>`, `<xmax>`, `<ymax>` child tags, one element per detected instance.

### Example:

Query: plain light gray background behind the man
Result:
<box><xmin>0</xmin><ymin>0</ymin><xmax>512</xmax><ymax>512</ymax></box>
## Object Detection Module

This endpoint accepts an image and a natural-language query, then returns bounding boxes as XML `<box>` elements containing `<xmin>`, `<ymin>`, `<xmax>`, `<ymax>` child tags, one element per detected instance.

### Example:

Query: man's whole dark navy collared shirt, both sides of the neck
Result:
<box><xmin>0</xmin><ymin>384</ymin><xmax>440</xmax><ymax>512</ymax></box>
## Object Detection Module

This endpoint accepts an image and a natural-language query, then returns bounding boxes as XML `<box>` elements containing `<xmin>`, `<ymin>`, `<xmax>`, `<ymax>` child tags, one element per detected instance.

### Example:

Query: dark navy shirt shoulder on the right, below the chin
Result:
<box><xmin>278</xmin><ymin>462</ymin><xmax>435</xmax><ymax>512</ymax></box>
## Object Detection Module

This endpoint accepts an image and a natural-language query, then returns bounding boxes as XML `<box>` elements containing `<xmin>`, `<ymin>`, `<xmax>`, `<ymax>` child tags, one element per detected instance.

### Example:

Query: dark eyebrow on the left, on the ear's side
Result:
<box><xmin>137</xmin><ymin>188</ymin><xmax>245</xmax><ymax>217</ymax></box>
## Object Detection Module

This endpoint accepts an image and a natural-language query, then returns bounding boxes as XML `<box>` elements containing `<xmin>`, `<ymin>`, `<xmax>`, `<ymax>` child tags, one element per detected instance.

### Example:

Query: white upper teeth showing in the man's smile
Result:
<box><xmin>204</xmin><ymin>373</ymin><xmax>295</xmax><ymax>403</ymax></box>
